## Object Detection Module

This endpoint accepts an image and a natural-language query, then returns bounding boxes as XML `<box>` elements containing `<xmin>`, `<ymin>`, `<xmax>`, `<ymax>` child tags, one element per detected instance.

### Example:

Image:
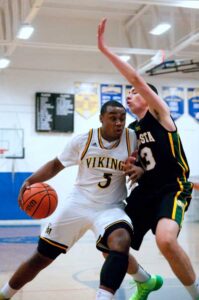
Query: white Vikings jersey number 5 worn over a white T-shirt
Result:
<box><xmin>58</xmin><ymin>128</ymin><xmax>136</xmax><ymax>207</ymax></box>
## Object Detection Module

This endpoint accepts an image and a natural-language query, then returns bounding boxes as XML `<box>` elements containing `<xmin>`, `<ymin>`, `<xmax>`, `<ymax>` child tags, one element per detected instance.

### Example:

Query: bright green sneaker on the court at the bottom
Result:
<box><xmin>129</xmin><ymin>275</ymin><xmax>163</xmax><ymax>300</ymax></box>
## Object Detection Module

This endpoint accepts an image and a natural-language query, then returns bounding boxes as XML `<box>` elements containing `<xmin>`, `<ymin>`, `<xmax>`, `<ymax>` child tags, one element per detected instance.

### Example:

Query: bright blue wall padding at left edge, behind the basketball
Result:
<box><xmin>0</xmin><ymin>172</ymin><xmax>32</xmax><ymax>220</ymax></box>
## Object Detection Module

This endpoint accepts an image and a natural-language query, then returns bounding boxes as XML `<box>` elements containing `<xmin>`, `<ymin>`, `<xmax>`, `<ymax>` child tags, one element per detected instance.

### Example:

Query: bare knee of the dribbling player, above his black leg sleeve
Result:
<box><xmin>107</xmin><ymin>228</ymin><xmax>131</xmax><ymax>253</ymax></box>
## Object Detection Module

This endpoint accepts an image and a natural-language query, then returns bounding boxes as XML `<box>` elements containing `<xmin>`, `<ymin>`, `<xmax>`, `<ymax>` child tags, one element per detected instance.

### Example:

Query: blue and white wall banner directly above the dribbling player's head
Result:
<box><xmin>100</xmin><ymin>84</ymin><xmax>122</xmax><ymax>106</ymax></box>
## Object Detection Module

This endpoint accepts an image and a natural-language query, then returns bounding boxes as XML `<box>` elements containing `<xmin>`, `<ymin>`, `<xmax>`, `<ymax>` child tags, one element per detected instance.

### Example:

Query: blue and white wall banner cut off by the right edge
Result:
<box><xmin>187</xmin><ymin>88</ymin><xmax>199</xmax><ymax>121</ymax></box>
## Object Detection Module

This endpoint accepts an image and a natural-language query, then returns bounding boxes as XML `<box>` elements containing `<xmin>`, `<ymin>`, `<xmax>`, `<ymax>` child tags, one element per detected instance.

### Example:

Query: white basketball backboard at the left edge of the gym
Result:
<box><xmin>0</xmin><ymin>128</ymin><xmax>24</xmax><ymax>159</ymax></box>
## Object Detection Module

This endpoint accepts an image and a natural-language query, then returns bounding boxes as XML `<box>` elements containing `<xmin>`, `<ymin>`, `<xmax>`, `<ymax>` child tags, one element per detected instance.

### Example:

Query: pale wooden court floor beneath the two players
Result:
<box><xmin>0</xmin><ymin>221</ymin><xmax>199</xmax><ymax>300</ymax></box>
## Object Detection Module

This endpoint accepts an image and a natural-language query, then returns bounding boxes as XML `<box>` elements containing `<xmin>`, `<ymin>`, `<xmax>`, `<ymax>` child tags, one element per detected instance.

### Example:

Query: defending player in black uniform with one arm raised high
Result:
<box><xmin>98</xmin><ymin>19</ymin><xmax>199</xmax><ymax>299</ymax></box>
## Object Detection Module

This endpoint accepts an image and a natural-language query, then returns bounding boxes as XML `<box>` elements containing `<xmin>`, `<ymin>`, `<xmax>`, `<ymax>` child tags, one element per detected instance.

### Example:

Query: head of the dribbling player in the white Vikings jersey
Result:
<box><xmin>100</xmin><ymin>100</ymin><xmax>126</xmax><ymax>141</ymax></box>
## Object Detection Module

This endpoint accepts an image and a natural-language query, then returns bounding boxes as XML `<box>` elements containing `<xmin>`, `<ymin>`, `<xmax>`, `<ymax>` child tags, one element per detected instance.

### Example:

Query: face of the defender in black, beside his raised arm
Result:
<box><xmin>126</xmin><ymin>88</ymin><xmax>147</xmax><ymax>116</ymax></box>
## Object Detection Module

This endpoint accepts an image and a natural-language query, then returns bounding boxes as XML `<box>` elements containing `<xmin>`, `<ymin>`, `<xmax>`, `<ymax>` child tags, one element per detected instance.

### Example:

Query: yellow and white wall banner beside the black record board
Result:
<box><xmin>75</xmin><ymin>82</ymin><xmax>99</xmax><ymax>119</ymax></box>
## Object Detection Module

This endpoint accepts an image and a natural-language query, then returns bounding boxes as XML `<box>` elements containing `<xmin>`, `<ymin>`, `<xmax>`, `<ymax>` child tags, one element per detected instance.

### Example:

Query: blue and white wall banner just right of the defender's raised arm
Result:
<box><xmin>162</xmin><ymin>86</ymin><xmax>185</xmax><ymax>120</ymax></box>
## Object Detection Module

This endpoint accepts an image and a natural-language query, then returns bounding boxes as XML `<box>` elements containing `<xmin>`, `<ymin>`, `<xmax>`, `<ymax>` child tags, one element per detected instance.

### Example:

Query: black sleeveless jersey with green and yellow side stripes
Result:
<box><xmin>129</xmin><ymin>111</ymin><xmax>189</xmax><ymax>189</ymax></box>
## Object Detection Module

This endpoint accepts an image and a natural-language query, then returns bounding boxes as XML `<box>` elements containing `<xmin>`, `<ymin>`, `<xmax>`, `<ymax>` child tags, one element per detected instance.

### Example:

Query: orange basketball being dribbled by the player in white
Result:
<box><xmin>22</xmin><ymin>182</ymin><xmax>58</xmax><ymax>219</ymax></box>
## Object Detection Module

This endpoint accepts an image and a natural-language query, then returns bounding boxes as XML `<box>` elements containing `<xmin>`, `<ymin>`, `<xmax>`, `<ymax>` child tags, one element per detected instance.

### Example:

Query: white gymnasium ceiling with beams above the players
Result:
<box><xmin>0</xmin><ymin>0</ymin><xmax>199</xmax><ymax>73</ymax></box>
